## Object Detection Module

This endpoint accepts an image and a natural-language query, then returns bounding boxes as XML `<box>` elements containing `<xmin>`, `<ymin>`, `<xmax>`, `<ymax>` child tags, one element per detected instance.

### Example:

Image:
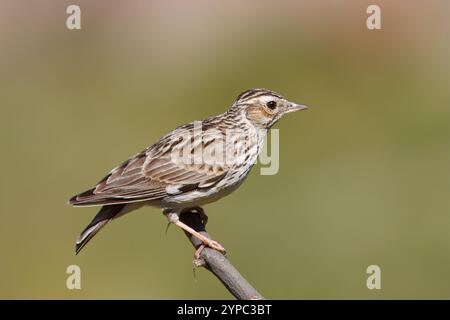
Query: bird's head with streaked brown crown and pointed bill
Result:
<box><xmin>234</xmin><ymin>89</ymin><xmax>308</xmax><ymax>129</ymax></box>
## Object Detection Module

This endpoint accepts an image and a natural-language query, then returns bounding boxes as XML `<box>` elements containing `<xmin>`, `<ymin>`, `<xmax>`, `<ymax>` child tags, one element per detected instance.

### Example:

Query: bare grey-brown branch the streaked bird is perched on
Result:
<box><xmin>180</xmin><ymin>209</ymin><xmax>265</xmax><ymax>300</ymax></box>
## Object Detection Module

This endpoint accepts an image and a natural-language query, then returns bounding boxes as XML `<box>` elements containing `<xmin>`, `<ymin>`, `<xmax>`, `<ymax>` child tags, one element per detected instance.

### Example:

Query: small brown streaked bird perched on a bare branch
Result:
<box><xmin>69</xmin><ymin>88</ymin><xmax>308</xmax><ymax>256</ymax></box>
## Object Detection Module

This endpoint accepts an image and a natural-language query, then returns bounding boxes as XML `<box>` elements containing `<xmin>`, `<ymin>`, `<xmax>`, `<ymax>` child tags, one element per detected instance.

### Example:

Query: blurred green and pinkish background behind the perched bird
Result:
<box><xmin>0</xmin><ymin>0</ymin><xmax>450</xmax><ymax>299</ymax></box>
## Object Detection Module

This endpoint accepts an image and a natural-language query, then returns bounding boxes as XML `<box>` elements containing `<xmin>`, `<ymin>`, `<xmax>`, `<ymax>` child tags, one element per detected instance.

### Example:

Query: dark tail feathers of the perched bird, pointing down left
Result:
<box><xmin>75</xmin><ymin>204</ymin><xmax>125</xmax><ymax>254</ymax></box>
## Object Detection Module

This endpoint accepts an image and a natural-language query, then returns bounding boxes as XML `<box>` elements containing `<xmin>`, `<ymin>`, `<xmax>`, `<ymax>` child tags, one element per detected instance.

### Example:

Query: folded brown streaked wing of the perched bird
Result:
<box><xmin>70</xmin><ymin>126</ymin><xmax>229</xmax><ymax>206</ymax></box>
